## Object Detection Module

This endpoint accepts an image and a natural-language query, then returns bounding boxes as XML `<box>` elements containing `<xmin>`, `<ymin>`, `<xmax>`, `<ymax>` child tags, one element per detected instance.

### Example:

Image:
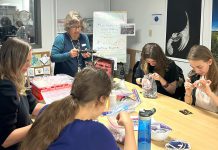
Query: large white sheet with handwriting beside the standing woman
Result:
<box><xmin>93</xmin><ymin>11</ymin><xmax>127</xmax><ymax>63</ymax></box>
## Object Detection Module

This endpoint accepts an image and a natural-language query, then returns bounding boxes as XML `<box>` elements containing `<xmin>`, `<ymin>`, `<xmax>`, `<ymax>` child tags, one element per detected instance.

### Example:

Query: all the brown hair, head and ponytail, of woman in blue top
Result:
<box><xmin>21</xmin><ymin>68</ymin><xmax>112</xmax><ymax>150</ymax></box>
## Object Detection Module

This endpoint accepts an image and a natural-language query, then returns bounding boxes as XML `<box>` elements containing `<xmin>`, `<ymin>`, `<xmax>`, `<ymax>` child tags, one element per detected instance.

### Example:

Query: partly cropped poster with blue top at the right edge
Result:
<box><xmin>211</xmin><ymin>0</ymin><xmax>218</xmax><ymax>64</ymax></box>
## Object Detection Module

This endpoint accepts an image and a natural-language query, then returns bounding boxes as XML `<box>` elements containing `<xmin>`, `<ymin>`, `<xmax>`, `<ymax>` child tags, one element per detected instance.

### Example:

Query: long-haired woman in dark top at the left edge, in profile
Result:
<box><xmin>0</xmin><ymin>38</ymin><xmax>44</xmax><ymax>150</ymax></box>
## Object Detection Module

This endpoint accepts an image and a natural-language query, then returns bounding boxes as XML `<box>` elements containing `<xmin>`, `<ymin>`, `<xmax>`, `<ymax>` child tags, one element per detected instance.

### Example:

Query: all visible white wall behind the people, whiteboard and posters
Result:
<box><xmin>38</xmin><ymin>0</ymin><xmax>212</xmax><ymax>75</ymax></box>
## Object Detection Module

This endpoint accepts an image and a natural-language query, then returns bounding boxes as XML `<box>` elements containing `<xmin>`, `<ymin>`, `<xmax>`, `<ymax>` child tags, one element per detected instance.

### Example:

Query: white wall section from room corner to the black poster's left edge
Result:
<box><xmin>111</xmin><ymin>0</ymin><xmax>166</xmax><ymax>50</ymax></box>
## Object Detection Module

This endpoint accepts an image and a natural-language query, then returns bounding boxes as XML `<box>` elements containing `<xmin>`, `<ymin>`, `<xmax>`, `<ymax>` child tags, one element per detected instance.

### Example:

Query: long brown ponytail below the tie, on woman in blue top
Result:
<box><xmin>20</xmin><ymin>95</ymin><xmax>79</xmax><ymax>150</ymax></box>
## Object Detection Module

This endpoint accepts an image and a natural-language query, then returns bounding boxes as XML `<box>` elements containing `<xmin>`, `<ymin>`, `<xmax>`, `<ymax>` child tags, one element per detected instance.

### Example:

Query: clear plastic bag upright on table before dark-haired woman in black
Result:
<box><xmin>142</xmin><ymin>74</ymin><xmax>157</xmax><ymax>98</ymax></box>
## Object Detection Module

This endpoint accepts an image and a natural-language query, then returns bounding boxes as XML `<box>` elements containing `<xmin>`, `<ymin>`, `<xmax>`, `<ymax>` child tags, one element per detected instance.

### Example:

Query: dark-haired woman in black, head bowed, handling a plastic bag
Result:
<box><xmin>135</xmin><ymin>43</ymin><xmax>184</xmax><ymax>100</ymax></box>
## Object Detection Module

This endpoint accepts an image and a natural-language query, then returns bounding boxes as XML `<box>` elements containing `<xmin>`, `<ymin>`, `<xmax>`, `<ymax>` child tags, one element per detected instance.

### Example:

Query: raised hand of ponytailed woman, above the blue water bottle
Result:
<box><xmin>116</xmin><ymin>112</ymin><xmax>133</xmax><ymax>128</ymax></box>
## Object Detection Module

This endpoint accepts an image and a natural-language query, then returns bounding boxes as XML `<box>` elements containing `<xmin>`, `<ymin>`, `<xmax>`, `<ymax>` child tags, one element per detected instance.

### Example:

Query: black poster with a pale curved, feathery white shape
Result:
<box><xmin>165</xmin><ymin>0</ymin><xmax>201</xmax><ymax>61</ymax></box>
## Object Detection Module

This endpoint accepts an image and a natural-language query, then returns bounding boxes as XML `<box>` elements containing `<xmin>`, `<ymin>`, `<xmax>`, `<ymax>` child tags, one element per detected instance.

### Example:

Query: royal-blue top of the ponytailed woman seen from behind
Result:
<box><xmin>48</xmin><ymin>119</ymin><xmax>119</xmax><ymax>150</ymax></box>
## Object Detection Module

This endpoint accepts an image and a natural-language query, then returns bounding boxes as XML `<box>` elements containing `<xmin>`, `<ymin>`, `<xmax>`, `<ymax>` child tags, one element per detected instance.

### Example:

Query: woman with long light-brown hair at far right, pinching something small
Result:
<box><xmin>185</xmin><ymin>45</ymin><xmax>218</xmax><ymax>113</ymax></box>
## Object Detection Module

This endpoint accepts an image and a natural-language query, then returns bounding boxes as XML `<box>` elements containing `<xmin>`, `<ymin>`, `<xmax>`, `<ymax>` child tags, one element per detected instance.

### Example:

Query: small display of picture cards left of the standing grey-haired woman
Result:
<box><xmin>27</xmin><ymin>51</ymin><xmax>51</xmax><ymax>77</ymax></box>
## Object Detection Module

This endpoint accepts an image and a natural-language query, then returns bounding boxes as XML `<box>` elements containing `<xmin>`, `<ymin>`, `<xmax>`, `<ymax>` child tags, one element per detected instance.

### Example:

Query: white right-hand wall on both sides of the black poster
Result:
<box><xmin>111</xmin><ymin>0</ymin><xmax>212</xmax><ymax>76</ymax></box>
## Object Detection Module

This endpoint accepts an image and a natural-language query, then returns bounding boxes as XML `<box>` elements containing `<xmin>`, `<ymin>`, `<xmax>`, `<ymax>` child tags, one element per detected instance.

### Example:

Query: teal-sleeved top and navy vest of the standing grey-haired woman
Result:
<box><xmin>51</xmin><ymin>32</ymin><xmax>91</xmax><ymax>77</ymax></box>
